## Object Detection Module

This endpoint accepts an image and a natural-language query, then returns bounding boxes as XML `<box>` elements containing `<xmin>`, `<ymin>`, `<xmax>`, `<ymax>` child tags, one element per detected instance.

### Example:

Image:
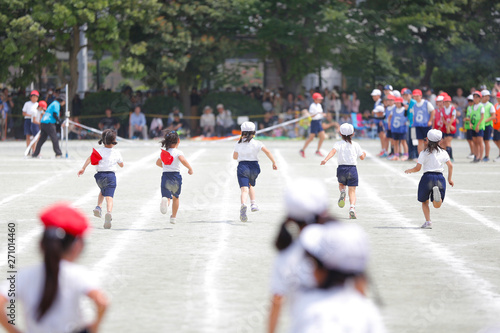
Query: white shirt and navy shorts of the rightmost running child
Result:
<box><xmin>417</xmin><ymin>148</ymin><xmax>450</xmax><ymax>202</ymax></box>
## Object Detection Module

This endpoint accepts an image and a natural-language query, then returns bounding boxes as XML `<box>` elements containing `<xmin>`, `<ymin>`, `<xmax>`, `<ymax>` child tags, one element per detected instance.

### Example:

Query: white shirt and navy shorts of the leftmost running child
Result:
<box><xmin>94</xmin><ymin>147</ymin><xmax>123</xmax><ymax>197</ymax></box>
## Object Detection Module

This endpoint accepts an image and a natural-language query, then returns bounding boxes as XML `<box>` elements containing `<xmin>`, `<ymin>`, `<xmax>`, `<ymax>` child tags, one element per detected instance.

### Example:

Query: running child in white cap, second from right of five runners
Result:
<box><xmin>321</xmin><ymin>123</ymin><xmax>366</xmax><ymax>219</ymax></box>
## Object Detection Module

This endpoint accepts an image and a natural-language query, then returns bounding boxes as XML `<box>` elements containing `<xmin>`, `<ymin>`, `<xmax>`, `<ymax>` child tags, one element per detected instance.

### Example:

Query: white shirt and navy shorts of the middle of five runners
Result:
<box><xmin>234</xmin><ymin>139</ymin><xmax>264</xmax><ymax>187</ymax></box>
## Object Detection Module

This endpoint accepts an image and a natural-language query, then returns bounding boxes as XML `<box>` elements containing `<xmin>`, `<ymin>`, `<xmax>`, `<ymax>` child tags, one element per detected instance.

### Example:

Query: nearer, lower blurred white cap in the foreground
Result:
<box><xmin>299</xmin><ymin>222</ymin><xmax>369</xmax><ymax>273</ymax></box>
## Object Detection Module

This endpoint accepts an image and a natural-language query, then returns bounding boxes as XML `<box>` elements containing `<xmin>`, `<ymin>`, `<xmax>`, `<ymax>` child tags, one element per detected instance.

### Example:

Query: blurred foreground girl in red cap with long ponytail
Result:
<box><xmin>0</xmin><ymin>204</ymin><xmax>108</xmax><ymax>333</ymax></box>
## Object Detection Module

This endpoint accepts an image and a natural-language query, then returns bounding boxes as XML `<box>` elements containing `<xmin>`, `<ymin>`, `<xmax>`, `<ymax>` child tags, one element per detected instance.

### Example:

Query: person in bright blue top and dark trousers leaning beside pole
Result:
<box><xmin>33</xmin><ymin>94</ymin><xmax>66</xmax><ymax>158</ymax></box>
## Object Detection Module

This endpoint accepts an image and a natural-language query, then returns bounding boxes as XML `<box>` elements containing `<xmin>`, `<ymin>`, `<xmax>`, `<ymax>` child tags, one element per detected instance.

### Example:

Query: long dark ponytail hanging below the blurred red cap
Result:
<box><xmin>37</xmin><ymin>228</ymin><xmax>76</xmax><ymax>321</ymax></box>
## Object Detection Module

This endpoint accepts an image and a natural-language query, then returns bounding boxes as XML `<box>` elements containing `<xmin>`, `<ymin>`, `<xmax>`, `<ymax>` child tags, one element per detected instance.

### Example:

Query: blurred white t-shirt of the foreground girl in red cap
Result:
<box><xmin>0</xmin><ymin>260</ymin><xmax>98</xmax><ymax>333</ymax></box>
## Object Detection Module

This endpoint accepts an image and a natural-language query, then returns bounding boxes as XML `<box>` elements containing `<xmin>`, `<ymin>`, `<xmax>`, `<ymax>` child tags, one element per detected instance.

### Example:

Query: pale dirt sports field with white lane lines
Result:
<box><xmin>0</xmin><ymin>136</ymin><xmax>500</xmax><ymax>333</ymax></box>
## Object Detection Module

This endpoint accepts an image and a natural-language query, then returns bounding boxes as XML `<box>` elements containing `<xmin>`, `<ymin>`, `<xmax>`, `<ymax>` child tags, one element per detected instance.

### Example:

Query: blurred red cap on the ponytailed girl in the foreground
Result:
<box><xmin>40</xmin><ymin>203</ymin><xmax>89</xmax><ymax>236</ymax></box>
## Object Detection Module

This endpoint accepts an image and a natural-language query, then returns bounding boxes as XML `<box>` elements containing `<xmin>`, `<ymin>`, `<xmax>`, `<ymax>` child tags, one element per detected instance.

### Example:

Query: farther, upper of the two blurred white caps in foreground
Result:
<box><xmin>285</xmin><ymin>178</ymin><xmax>328</xmax><ymax>223</ymax></box>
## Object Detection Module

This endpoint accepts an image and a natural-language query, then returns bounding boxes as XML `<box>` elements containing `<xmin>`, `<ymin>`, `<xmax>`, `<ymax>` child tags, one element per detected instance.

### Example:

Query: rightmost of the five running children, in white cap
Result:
<box><xmin>405</xmin><ymin>129</ymin><xmax>454</xmax><ymax>229</ymax></box>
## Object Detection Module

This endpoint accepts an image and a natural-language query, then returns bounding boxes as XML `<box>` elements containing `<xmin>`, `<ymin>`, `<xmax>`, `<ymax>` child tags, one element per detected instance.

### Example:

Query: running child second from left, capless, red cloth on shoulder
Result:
<box><xmin>156</xmin><ymin>131</ymin><xmax>193</xmax><ymax>224</ymax></box>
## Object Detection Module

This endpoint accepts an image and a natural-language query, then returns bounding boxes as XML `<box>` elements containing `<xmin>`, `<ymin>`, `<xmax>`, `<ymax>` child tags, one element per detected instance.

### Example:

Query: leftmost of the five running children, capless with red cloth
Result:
<box><xmin>78</xmin><ymin>129</ymin><xmax>123</xmax><ymax>229</ymax></box>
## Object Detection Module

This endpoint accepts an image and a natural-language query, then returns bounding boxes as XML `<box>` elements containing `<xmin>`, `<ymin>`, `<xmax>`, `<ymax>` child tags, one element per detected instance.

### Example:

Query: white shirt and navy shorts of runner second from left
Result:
<box><xmin>161</xmin><ymin>148</ymin><xmax>184</xmax><ymax>199</ymax></box>
